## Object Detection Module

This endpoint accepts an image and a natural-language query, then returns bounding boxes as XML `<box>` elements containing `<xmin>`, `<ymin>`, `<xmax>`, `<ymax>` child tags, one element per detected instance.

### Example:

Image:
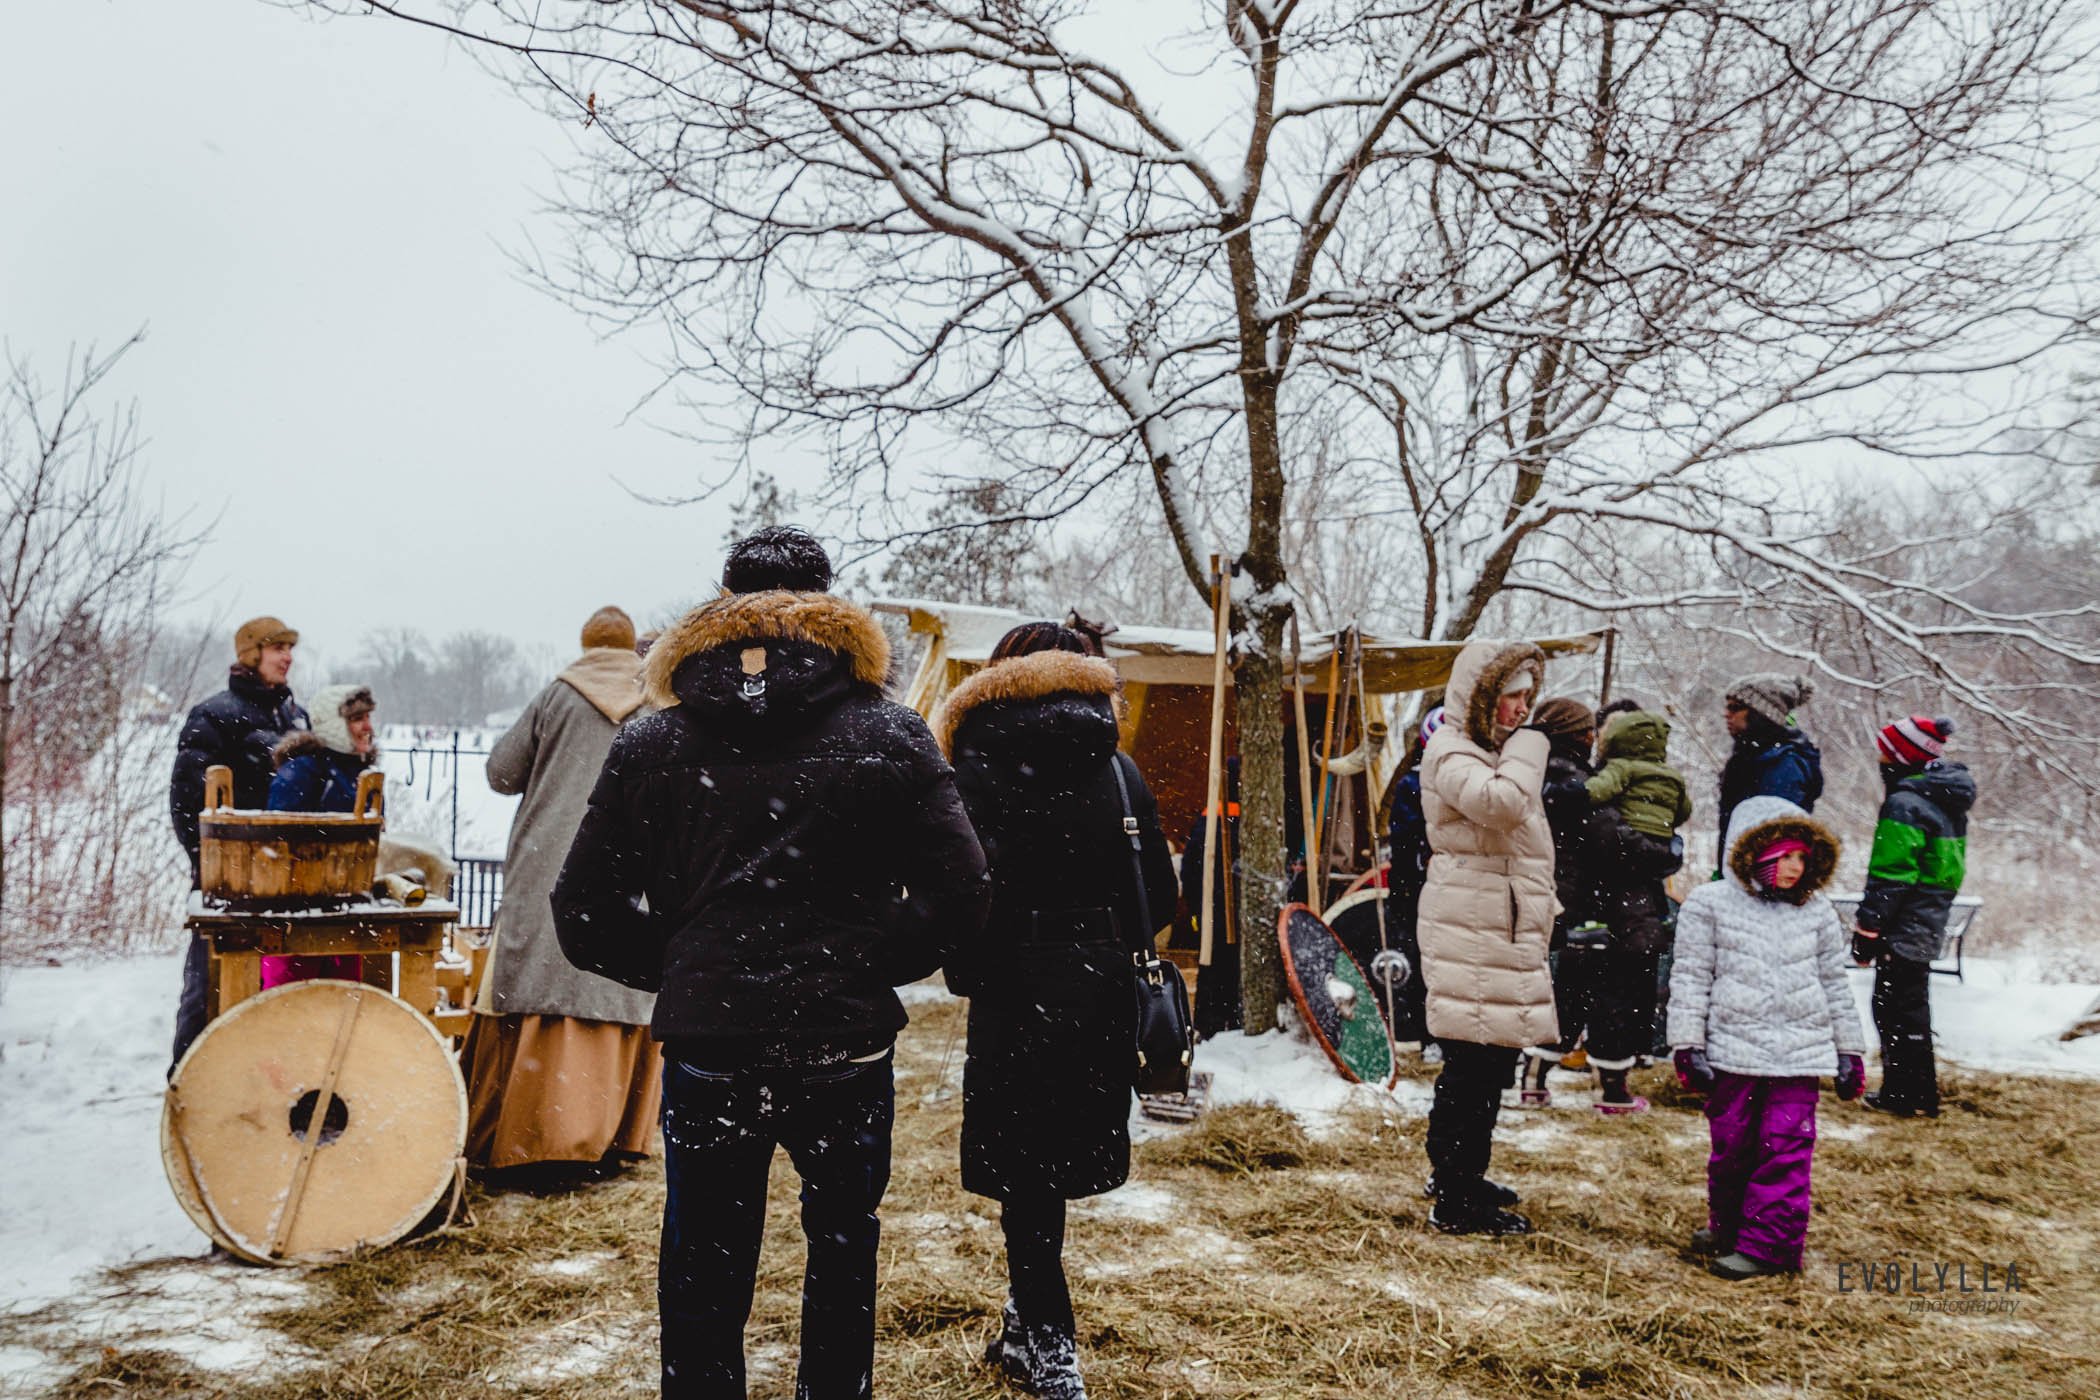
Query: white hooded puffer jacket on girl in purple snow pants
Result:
<box><xmin>1670</xmin><ymin>798</ymin><xmax>1867</xmax><ymax>1079</ymax></box>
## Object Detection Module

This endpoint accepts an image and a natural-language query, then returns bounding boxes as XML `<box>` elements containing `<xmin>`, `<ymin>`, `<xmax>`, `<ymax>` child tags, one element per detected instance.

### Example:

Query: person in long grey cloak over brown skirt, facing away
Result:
<box><xmin>462</xmin><ymin>607</ymin><xmax>664</xmax><ymax>1167</ymax></box>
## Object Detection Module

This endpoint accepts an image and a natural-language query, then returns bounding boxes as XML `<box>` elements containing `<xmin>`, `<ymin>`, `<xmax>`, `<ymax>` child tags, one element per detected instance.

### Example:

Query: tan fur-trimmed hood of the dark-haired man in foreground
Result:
<box><xmin>643</xmin><ymin>592</ymin><xmax>890</xmax><ymax>728</ymax></box>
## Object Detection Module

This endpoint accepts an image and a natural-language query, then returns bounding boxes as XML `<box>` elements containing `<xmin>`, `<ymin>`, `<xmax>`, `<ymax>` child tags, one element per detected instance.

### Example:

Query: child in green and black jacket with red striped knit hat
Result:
<box><xmin>1852</xmin><ymin>714</ymin><xmax>1976</xmax><ymax>1119</ymax></box>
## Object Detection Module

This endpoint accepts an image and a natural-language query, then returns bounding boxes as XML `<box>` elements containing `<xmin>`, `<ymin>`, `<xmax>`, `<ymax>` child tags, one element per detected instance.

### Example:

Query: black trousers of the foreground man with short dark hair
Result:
<box><xmin>657</xmin><ymin>1056</ymin><xmax>895</xmax><ymax>1400</ymax></box>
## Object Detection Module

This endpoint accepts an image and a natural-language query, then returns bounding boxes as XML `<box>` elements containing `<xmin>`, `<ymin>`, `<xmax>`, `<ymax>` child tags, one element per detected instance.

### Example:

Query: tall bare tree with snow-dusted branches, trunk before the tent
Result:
<box><xmin>319</xmin><ymin>0</ymin><xmax>2087</xmax><ymax>1031</ymax></box>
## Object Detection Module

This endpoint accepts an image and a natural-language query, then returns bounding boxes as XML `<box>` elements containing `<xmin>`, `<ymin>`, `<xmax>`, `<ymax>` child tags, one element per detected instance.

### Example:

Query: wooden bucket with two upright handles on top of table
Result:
<box><xmin>197</xmin><ymin>766</ymin><xmax>386</xmax><ymax>909</ymax></box>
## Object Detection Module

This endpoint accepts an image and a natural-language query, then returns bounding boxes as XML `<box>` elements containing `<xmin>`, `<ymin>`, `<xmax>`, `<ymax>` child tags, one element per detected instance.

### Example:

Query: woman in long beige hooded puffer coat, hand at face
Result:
<box><xmin>1415</xmin><ymin>642</ymin><xmax>1560</xmax><ymax>1234</ymax></box>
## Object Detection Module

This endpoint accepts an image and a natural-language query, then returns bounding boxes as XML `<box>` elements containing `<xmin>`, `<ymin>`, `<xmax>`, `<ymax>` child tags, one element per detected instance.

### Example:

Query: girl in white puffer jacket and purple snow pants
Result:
<box><xmin>1670</xmin><ymin>798</ymin><xmax>1867</xmax><ymax>1280</ymax></box>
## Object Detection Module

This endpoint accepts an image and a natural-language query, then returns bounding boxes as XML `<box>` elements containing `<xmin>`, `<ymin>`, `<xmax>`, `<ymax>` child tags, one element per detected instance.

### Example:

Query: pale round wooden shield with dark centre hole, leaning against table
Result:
<box><xmin>160</xmin><ymin>980</ymin><xmax>466</xmax><ymax>1264</ymax></box>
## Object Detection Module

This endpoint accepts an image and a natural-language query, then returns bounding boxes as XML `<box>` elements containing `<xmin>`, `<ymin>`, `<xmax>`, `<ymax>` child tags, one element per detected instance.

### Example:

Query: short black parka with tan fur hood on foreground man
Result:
<box><xmin>552</xmin><ymin>592</ymin><xmax>989</xmax><ymax>1068</ymax></box>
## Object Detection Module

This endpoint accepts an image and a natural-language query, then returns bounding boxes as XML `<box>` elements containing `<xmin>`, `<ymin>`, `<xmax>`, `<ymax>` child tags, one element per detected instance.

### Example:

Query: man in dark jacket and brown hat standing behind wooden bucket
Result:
<box><xmin>168</xmin><ymin>617</ymin><xmax>311</xmax><ymax>1075</ymax></box>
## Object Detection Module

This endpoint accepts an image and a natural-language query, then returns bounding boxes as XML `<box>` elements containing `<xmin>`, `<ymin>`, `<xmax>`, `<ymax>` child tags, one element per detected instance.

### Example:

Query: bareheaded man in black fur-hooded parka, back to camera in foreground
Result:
<box><xmin>552</xmin><ymin>527</ymin><xmax>989</xmax><ymax>1400</ymax></box>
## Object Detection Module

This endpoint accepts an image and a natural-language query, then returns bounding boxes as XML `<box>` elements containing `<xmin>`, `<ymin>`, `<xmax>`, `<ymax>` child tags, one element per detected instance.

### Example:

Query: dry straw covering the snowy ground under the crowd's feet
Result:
<box><xmin>0</xmin><ymin>1003</ymin><xmax>2100</xmax><ymax>1400</ymax></box>
